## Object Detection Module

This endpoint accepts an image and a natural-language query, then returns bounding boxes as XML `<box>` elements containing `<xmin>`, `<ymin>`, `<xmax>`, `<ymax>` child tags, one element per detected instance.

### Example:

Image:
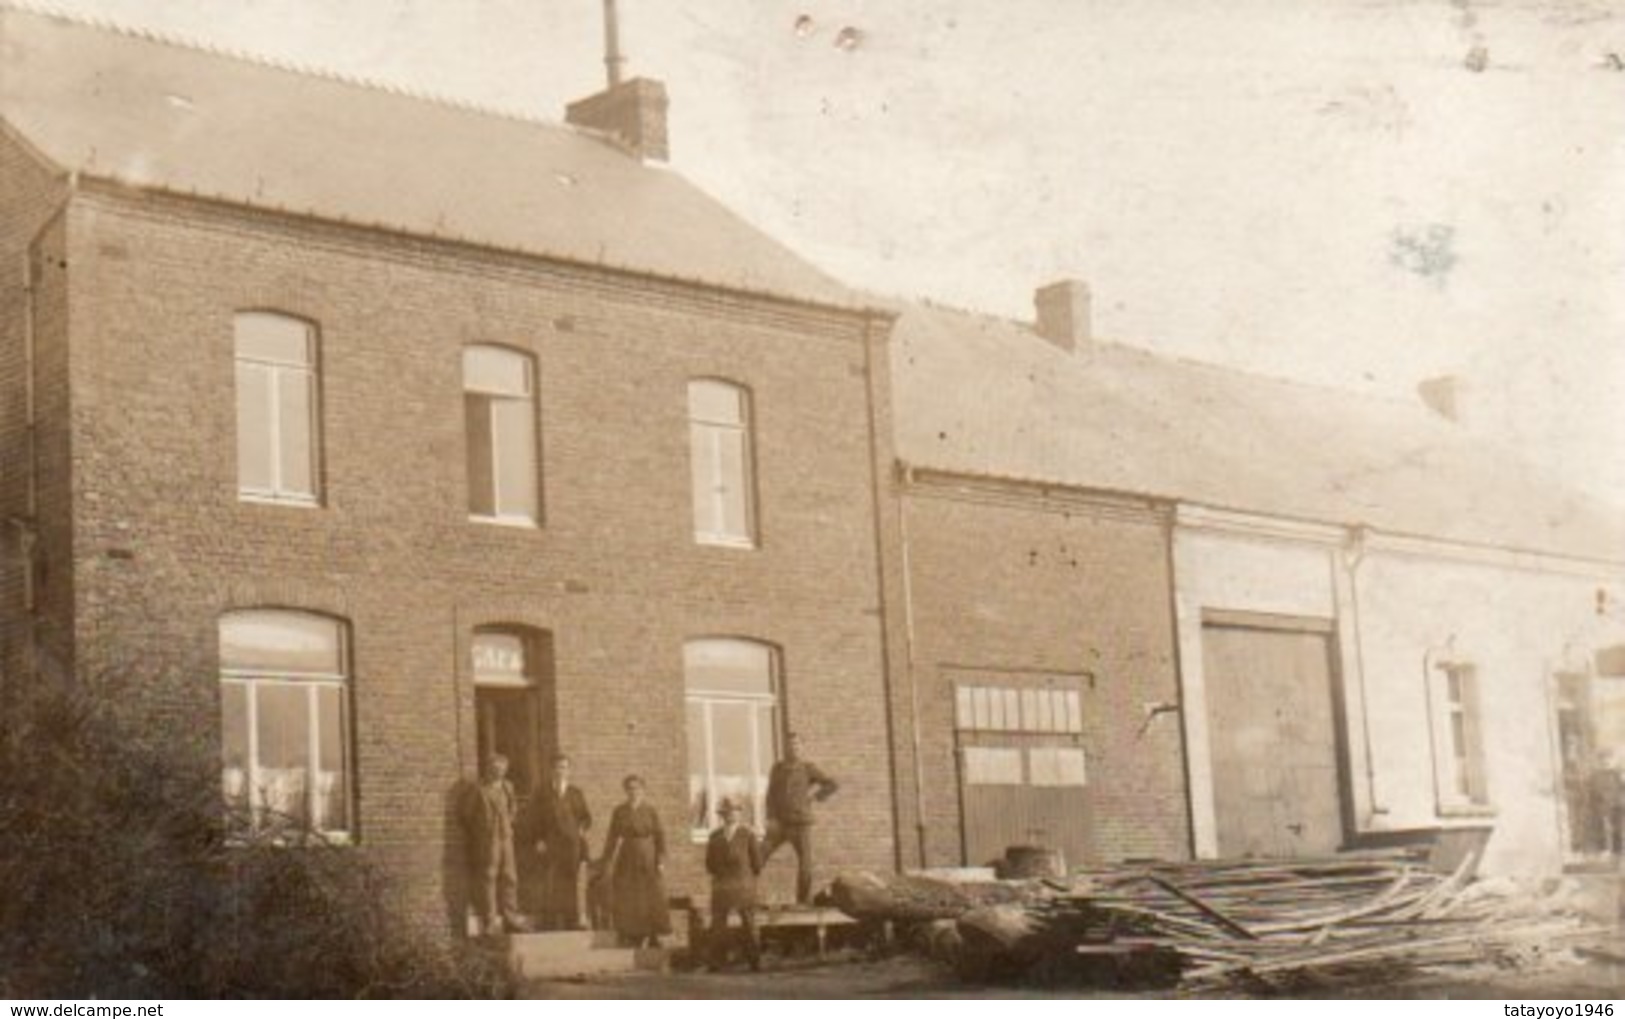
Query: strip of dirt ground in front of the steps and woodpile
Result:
<box><xmin>522</xmin><ymin>943</ymin><xmax>1625</xmax><ymax>1001</ymax></box>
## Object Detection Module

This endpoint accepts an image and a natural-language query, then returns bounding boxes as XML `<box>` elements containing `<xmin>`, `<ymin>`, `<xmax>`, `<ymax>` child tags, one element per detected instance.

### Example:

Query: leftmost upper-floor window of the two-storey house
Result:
<box><xmin>234</xmin><ymin>312</ymin><xmax>322</xmax><ymax>502</ymax></box>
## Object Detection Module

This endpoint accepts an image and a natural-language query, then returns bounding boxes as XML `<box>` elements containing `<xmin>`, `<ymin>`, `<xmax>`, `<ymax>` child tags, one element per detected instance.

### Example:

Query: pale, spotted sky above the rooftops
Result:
<box><xmin>29</xmin><ymin>0</ymin><xmax>1625</xmax><ymax>505</ymax></box>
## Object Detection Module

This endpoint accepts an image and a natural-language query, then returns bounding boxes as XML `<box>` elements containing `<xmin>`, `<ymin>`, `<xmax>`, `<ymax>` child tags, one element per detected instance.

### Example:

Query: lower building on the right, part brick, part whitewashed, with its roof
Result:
<box><xmin>891</xmin><ymin>281</ymin><xmax>1625</xmax><ymax>873</ymax></box>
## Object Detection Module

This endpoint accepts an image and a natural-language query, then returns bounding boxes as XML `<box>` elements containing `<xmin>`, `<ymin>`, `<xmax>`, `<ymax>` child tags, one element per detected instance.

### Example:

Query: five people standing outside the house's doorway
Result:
<box><xmin>460</xmin><ymin>733</ymin><xmax>839</xmax><ymax>969</ymax></box>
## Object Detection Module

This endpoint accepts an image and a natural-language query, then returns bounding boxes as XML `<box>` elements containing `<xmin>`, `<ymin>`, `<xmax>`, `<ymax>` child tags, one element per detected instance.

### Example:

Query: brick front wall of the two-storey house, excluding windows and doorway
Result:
<box><xmin>50</xmin><ymin>185</ymin><xmax>894</xmax><ymax>923</ymax></box>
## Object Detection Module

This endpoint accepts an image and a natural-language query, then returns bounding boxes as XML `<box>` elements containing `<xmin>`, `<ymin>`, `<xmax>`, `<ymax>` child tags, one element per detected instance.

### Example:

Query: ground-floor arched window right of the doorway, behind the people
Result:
<box><xmin>683</xmin><ymin>637</ymin><xmax>780</xmax><ymax>834</ymax></box>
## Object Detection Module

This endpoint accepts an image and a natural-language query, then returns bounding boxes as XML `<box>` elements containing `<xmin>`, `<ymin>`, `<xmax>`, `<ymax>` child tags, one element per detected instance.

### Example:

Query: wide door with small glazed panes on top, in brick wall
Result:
<box><xmin>956</xmin><ymin>684</ymin><xmax>1092</xmax><ymax>865</ymax></box>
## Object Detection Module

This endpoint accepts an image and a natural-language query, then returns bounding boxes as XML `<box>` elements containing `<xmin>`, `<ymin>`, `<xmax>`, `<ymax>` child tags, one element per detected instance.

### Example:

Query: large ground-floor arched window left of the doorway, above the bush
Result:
<box><xmin>219</xmin><ymin>609</ymin><xmax>353</xmax><ymax>835</ymax></box>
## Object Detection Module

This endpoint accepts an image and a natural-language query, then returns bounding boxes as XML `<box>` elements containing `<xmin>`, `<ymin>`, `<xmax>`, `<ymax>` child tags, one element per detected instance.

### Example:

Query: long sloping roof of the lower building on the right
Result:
<box><xmin>891</xmin><ymin>306</ymin><xmax>1625</xmax><ymax>562</ymax></box>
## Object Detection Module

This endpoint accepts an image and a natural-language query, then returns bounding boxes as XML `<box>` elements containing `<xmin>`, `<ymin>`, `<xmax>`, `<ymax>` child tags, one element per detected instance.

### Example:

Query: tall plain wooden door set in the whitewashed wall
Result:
<box><xmin>1203</xmin><ymin>624</ymin><xmax>1344</xmax><ymax>856</ymax></box>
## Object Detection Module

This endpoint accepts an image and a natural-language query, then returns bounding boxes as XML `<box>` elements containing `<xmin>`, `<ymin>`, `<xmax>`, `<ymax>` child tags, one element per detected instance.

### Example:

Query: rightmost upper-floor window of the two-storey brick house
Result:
<box><xmin>689</xmin><ymin>379</ymin><xmax>756</xmax><ymax>548</ymax></box>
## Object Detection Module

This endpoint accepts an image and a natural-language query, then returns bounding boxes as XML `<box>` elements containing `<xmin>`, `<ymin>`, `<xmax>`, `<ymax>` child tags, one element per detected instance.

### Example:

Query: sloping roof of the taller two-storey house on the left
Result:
<box><xmin>0</xmin><ymin>2</ymin><xmax>860</xmax><ymax>307</ymax></box>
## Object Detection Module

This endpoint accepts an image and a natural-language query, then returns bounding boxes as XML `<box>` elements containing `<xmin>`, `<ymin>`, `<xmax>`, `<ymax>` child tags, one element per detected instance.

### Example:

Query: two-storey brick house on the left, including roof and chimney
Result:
<box><xmin>0</xmin><ymin>7</ymin><xmax>894</xmax><ymax>925</ymax></box>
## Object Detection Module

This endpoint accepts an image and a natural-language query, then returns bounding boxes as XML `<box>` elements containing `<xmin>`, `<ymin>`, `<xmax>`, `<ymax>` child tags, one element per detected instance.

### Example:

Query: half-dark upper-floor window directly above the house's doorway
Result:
<box><xmin>463</xmin><ymin>346</ymin><xmax>540</xmax><ymax>523</ymax></box>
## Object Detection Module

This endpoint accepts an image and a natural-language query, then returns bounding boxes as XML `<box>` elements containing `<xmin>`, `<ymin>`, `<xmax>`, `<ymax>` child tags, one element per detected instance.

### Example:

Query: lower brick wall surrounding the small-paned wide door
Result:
<box><xmin>892</xmin><ymin>476</ymin><xmax>1190</xmax><ymax>866</ymax></box>
